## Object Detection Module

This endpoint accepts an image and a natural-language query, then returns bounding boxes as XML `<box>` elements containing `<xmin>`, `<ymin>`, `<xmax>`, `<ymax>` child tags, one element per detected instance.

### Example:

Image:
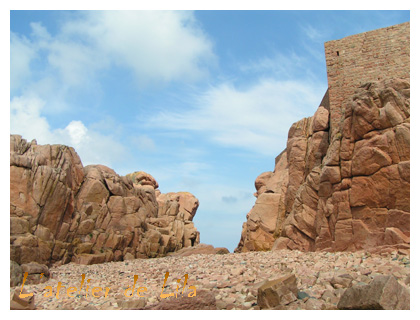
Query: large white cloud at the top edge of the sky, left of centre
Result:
<box><xmin>50</xmin><ymin>11</ymin><xmax>215</xmax><ymax>84</ymax></box>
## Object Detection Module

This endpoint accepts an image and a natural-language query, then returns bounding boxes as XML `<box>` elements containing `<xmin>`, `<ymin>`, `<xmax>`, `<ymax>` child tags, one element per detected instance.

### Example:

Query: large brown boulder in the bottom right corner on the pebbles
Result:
<box><xmin>337</xmin><ymin>276</ymin><xmax>410</xmax><ymax>310</ymax></box>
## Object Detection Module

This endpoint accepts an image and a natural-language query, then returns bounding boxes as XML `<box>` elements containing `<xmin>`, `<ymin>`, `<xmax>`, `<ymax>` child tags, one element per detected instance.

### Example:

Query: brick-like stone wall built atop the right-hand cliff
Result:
<box><xmin>325</xmin><ymin>22</ymin><xmax>410</xmax><ymax>135</ymax></box>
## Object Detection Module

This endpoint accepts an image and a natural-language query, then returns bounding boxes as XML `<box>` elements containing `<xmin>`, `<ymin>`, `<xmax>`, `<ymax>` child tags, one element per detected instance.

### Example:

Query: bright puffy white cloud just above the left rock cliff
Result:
<box><xmin>10</xmin><ymin>96</ymin><xmax>128</xmax><ymax>168</ymax></box>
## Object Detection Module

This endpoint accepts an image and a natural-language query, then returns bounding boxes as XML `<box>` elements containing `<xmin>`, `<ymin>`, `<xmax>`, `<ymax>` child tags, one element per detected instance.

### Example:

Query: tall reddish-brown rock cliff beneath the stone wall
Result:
<box><xmin>236</xmin><ymin>79</ymin><xmax>410</xmax><ymax>252</ymax></box>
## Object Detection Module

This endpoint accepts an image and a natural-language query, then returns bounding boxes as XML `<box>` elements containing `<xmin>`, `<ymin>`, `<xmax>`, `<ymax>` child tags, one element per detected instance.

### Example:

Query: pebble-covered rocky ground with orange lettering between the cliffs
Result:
<box><xmin>10</xmin><ymin>250</ymin><xmax>410</xmax><ymax>310</ymax></box>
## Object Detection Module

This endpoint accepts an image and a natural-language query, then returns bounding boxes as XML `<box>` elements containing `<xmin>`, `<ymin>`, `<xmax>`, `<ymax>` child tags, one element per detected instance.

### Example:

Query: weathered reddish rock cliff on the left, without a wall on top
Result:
<box><xmin>10</xmin><ymin>135</ymin><xmax>199</xmax><ymax>265</ymax></box>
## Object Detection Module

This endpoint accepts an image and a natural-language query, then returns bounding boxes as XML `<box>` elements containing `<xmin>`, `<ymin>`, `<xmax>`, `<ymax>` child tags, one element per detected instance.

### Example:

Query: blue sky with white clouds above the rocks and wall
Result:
<box><xmin>10</xmin><ymin>11</ymin><xmax>410</xmax><ymax>251</ymax></box>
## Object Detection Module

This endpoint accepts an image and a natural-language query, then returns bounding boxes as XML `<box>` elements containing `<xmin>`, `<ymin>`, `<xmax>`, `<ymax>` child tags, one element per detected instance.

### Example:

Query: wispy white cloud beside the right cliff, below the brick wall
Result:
<box><xmin>150</xmin><ymin>79</ymin><xmax>326</xmax><ymax>155</ymax></box>
